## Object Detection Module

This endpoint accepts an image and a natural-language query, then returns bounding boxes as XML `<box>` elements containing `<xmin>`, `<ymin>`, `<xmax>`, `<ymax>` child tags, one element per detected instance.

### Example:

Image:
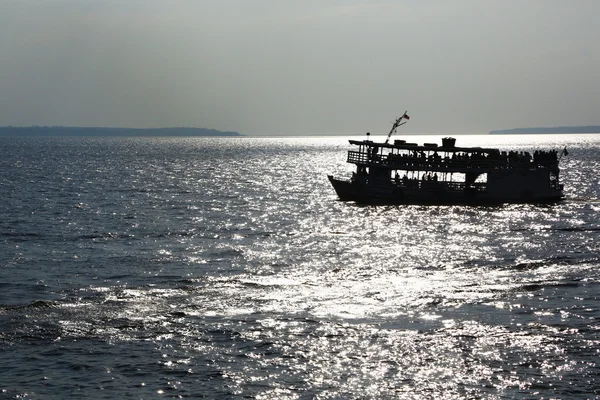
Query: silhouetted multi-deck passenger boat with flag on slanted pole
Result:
<box><xmin>328</xmin><ymin>112</ymin><xmax>566</xmax><ymax>205</ymax></box>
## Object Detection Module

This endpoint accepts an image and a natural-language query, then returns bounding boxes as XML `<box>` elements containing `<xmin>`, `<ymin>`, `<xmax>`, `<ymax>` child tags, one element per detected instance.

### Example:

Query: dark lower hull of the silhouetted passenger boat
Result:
<box><xmin>328</xmin><ymin>175</ymin><xmax>564</xmax><ymax>205</ymax></box>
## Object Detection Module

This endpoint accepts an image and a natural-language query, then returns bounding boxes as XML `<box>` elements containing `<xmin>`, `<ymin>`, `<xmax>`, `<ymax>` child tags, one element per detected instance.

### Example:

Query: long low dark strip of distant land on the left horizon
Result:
<box><xmin>0</xmin><ymin>126</ymin><xmax>244</xmax><ymax>137</ymax></box>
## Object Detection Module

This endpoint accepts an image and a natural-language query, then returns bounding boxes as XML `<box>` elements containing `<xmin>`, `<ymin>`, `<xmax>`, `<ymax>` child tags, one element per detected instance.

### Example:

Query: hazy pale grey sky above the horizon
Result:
<box><xmin>0</xmin><ymin>0</ymin><xmax>600</xmax><ymax>135</ymax></box>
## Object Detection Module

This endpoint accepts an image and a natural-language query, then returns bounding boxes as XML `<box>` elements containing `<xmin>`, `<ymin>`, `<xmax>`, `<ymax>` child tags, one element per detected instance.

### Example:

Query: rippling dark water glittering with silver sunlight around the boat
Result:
<box><xmin>0</xmin><ymin>134</ymin><xmax>600</xmax><ymax>399</ymax></box>
